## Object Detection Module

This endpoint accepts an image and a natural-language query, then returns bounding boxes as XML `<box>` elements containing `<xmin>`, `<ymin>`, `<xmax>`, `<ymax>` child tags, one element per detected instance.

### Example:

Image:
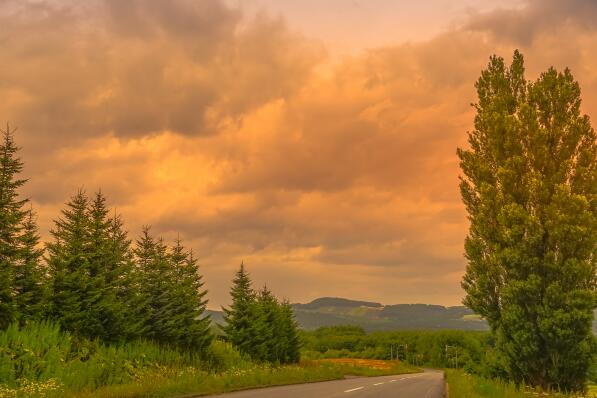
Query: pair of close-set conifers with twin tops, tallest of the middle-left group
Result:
<box><xmin>47</xmin><ymin>190</ymin><xmax>126</xmax><ymax>341</ymax></box>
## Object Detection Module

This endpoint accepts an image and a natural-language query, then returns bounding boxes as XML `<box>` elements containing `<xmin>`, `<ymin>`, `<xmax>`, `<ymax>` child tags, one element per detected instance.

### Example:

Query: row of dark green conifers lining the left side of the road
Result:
<box><xmin>0</xmin><ymin>128</ymin><xmax>299</xmax><ymax>363</ymax></box>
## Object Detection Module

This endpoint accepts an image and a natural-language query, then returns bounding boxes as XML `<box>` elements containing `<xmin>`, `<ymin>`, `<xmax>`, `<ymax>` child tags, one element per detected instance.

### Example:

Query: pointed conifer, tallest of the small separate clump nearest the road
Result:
<box><xmin>221</xmin><ymin>263</ymin><xmax>260</xmax><ymax>357</ymax></box>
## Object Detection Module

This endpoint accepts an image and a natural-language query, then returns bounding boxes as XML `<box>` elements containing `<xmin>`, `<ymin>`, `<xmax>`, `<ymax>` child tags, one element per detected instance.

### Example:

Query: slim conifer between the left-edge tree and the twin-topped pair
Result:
<box><xmin>15</xmin><ymin>209</ymin><xmax>47</xmax><ymax>324</ymax></box>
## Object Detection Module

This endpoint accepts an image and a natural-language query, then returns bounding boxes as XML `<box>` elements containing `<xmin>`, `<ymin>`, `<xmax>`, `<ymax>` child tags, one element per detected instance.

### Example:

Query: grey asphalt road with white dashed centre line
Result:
<box><xmin>207</xmin><ymin>371</ymin><xmax>444</xmax><ymax>398</ymax></box>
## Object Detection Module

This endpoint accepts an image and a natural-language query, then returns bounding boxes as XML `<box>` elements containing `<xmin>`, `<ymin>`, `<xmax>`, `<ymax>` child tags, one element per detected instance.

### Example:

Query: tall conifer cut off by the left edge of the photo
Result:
<box><xmin>0</xmin><ymin>126</ymin><xmax>27</xmax><ymax>329</ymax></box>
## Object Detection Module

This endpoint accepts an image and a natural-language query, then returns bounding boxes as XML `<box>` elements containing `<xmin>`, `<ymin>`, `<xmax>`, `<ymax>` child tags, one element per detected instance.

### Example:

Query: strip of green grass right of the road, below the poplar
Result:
<box><xmin>446</xmin><ymin>369</ymin><xmax>562</xmax><ymax>398</ymax></box>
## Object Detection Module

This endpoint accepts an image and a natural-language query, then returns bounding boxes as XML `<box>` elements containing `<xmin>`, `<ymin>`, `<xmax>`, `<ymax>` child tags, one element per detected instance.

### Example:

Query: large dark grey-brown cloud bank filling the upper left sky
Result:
<box><xmin>0</xmin><ymin>0</ymin><xmax>323</xmax><ymax>145</ymax></box>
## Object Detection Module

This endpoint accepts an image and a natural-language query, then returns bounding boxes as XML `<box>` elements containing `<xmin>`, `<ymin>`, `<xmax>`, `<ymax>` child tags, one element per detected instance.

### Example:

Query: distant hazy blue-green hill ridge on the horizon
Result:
<box><xmin>209</xmin><ymin>297</ymin><xmax>597</xmax><ymax>333</ymax></box>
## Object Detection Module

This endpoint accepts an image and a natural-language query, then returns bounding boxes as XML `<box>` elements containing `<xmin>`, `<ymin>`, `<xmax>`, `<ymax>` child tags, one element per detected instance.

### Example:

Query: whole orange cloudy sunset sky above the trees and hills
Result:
<box><xmin>0</xmin><ymin>0</ymin><xmax>597</xmax><ymax>308</ymax></box>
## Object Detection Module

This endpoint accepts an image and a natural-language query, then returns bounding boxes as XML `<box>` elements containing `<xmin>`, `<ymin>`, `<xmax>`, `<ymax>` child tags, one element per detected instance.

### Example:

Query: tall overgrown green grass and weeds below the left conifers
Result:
<box><xmin>0</xmin><ymin>322</ymin><xmax>233</xmax><ymax>397</ymax></box>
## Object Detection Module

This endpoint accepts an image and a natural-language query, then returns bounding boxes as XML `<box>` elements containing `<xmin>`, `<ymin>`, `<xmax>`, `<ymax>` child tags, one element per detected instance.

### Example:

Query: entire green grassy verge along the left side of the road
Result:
<box><xmin>0</xmin><ymin>323</ymin><xmax>417</xmax><ymax>398</ymax></box>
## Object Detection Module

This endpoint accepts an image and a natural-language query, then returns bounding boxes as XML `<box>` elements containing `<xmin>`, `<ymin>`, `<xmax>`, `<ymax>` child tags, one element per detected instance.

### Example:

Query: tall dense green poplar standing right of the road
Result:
<box><xmin>458</xmin><ymin>51</ymin><xmax>597</xmax><ymax>390</ymax></box>
